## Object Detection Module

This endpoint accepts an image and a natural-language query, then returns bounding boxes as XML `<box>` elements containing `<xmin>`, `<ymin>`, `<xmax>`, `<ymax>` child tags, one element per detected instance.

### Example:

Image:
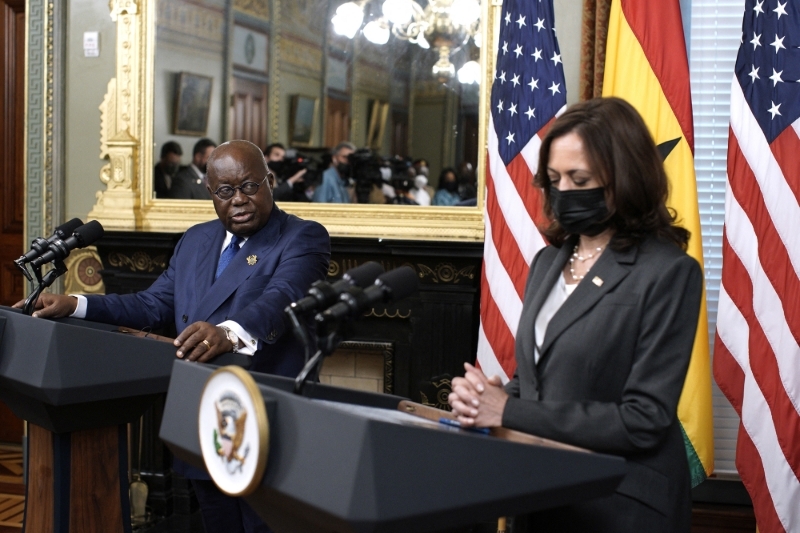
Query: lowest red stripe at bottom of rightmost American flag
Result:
<box><xmin>734</xmin><ymin>424</ymin><xmax>786</xmax><ymax>533</ymax></box>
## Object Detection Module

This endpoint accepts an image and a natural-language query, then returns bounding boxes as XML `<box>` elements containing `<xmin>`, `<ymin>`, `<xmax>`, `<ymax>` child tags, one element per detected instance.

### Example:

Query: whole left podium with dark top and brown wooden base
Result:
<box><xmin>0</xmin><ymin>307</ymin><xmax>249</xmax><ymax>533</ymax></box>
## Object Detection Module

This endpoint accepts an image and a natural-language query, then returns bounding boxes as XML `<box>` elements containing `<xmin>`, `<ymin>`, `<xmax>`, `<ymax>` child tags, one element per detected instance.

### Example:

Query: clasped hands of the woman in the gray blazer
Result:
<box><xmin>447</xmin><ymin>363</ymin><xmax>508</xmax><ymax>427</ymax></box>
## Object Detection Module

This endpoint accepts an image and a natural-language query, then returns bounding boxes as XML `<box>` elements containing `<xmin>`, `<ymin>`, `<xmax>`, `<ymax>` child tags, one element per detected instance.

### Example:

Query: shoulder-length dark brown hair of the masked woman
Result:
<box><xmin>534</xmin><ymin>98</ymin><xmax>690</xmax><ymax>250</ymax></box>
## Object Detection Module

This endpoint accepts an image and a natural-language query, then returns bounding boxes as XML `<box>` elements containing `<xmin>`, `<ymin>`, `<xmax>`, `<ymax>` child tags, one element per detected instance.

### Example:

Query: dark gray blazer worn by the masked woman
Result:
<box><xmin>503</xmin><ymin>237</ymin><xmax>703</xmax><ymax>533</ymax></box>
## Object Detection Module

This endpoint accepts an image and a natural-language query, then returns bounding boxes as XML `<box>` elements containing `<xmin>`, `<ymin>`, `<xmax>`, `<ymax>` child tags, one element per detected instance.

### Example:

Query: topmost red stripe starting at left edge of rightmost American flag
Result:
<box><xmin>728</xmin><ymin>133</ymin><xmax>800</xmax><ymax>343</ymax></box>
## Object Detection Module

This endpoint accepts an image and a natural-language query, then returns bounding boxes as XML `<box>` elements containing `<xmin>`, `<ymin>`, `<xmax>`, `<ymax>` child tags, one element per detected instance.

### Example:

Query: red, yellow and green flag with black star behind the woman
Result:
<box><xmin>603</xmin><ymin>0</ymin><xmax>714</xmax><ymax>486</ymax></box>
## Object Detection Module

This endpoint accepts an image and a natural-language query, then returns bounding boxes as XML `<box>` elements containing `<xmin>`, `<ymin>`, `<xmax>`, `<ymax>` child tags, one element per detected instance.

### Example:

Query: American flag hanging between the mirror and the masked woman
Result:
<box><xmin>478</xmin><ymin>0</ymin><xmax>567</xmax><ymax>382</ymax></box>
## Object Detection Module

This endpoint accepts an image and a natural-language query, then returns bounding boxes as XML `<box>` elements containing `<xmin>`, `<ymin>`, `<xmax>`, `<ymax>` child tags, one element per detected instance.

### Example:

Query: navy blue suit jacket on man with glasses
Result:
<box><xmin>86</xmin><ymin>207</ymin><xmax>330</xmax><ymax>376</ymax></box>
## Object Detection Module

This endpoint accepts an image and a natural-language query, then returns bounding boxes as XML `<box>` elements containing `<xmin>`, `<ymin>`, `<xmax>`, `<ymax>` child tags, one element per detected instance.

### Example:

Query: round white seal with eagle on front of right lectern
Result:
<box><xmin>198</xmin><ymin>366</ymin><xmax>269</xmax><ymax>496</ymax></box>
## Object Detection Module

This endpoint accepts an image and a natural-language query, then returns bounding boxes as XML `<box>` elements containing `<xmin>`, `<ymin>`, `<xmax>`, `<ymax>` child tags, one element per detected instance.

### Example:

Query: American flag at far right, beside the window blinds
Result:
<box><xmin>714</xmin><ymin>0</ymin><xmax>800</xmax><ymax>532</ymax></box>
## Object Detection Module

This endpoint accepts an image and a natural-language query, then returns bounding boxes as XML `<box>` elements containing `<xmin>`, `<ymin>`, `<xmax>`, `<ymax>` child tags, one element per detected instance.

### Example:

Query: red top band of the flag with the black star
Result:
<box><xmin>621</xmin><ymin>0</ymin><xmax>694</xmax><ymax>150</ymax></box>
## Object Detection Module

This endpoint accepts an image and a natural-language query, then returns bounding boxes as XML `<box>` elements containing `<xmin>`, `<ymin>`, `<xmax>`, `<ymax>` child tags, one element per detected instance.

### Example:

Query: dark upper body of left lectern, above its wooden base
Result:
<box><xmin>0</xmin><ymin>307</ymin><xmax>249</xmax><ymax>432</ymax></box>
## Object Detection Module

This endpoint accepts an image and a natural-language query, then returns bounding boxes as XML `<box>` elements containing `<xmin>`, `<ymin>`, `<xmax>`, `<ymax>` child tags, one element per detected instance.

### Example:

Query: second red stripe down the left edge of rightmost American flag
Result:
<box><xmin>722</xmin><ymin>238</ymin><xmax>800</xmax><ymax>479</ymax></box>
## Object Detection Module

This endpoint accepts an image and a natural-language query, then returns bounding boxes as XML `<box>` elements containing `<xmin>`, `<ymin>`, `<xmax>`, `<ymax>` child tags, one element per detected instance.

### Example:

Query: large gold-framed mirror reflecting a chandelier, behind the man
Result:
<box><xmin>87</xmin><ymin>0</ymin><xmax>492</xmax><ymax>240</ymax></box>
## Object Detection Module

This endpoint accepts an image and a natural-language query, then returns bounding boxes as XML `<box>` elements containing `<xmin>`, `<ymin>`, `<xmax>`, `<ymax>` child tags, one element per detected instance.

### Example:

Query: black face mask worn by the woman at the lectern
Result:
<box><xmin>550</xmin><ymin>187</ymin><xmax>608</xmax><ymax>237</ymax></box>
